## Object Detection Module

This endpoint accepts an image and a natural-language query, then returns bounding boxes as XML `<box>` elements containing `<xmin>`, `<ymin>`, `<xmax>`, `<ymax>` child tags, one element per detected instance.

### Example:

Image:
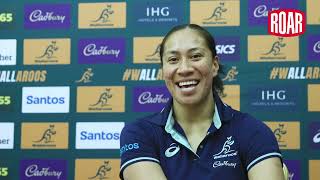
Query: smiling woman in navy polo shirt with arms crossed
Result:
<box><xmin>120</xmin><ymin>24</ymin><xmax>284</xmax><ymax>180</ymax></box>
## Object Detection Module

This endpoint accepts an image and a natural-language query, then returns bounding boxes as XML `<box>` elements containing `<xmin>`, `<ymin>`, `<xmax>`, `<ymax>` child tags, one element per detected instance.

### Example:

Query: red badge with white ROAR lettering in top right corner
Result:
<box><xmin>268</xmin><ymin>9</ymin><xmax>306</xmax><ymax>37</ymax></box>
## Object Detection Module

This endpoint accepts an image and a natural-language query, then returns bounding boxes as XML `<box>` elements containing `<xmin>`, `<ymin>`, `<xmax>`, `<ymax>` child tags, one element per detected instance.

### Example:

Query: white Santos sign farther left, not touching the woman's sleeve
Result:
<box><xmin>22</xmin><ymin>87</ymin><xmax>70</xmax><ymax>113</ymax></box>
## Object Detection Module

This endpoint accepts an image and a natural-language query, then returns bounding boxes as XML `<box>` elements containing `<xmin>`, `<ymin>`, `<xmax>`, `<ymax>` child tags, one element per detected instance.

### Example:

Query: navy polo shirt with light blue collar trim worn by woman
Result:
<box><xmin>120</xmin><ymin>93</ymin><xmax>281</xmax><ymax>180</ymax></box>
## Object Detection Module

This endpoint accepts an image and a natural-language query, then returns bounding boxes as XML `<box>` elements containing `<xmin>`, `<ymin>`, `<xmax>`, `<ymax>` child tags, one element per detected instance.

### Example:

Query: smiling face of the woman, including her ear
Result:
<box><xmin>162</xmin><ymin>28</ymin><xmax>219</xmax><ymax>105</ymax></box>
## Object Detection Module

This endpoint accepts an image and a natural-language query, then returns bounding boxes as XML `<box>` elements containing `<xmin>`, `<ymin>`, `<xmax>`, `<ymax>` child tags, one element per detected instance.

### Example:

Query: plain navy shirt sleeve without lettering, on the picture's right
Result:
<box><xmin>239</xmin><ymin>116</ymin><xmax>282</xmax><ymax>172</ymax></box>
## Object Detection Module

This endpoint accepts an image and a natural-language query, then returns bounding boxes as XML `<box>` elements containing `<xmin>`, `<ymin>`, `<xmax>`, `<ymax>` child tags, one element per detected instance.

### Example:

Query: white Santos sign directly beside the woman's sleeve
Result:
<box><xmin>76</xmin><ymin>122</ymin><xmax>124</xmax><ymax>149</ymax></box>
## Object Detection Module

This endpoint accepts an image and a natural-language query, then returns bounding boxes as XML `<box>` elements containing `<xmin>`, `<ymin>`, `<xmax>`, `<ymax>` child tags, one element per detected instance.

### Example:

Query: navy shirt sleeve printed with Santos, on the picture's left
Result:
<box><xmin>120</xmin><ymin>122</ymin><xmax>160</xmax><ymax>179</ymax></box>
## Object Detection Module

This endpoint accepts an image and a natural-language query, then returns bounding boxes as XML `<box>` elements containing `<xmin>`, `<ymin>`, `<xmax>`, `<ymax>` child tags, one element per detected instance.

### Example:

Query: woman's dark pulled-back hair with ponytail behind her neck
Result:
<box><xmin>160</xmin><ymin>24</ymin><xmax>224</xmax><ymax>95</ymax></box>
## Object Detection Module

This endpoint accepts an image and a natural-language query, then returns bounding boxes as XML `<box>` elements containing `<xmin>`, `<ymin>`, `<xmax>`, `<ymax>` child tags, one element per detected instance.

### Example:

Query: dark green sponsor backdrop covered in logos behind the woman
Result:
<box><xmin>0</xmin><ymin>0</ymin><xmax>320</xmax><ymax>180</ymax></box>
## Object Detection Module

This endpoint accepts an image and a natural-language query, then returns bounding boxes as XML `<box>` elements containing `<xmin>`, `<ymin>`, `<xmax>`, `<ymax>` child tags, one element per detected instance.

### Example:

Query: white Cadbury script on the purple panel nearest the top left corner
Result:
<box><xmin>29</xmin><ymin>9</ymin><xmax>66</xmax><ymax>23</ymax></box>
